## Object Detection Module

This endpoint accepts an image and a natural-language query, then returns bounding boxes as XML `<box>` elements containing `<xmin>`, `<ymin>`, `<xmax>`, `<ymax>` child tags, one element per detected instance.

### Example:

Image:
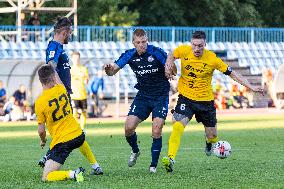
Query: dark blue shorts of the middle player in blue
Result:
<box><xmin>128</xmin><ymin>94</ymin><xmax>169</xmax><ymax>121</ymax></box>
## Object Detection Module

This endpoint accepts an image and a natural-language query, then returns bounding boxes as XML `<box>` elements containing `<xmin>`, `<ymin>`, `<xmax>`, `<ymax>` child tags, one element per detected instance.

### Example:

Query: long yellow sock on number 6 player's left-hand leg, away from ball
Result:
<box><xmin>168</xmin><ymin>121</ymin><xmax>184</xmax><ymax>159</ymax></box>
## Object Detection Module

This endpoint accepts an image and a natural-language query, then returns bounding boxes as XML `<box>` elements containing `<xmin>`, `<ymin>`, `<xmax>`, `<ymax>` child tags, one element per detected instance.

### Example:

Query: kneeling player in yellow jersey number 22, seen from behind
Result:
<box><xmin>35</xmin><ymin>64</ymin><xmax>102</xmax><ymax>182</ymax></box>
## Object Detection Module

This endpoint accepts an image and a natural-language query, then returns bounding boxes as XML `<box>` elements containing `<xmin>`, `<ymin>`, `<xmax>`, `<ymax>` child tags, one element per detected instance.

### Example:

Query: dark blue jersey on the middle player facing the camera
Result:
<box><xmin>115</xmin><ymin>45</ymin><xmax>170</xmax><ymax>96</ymax></box>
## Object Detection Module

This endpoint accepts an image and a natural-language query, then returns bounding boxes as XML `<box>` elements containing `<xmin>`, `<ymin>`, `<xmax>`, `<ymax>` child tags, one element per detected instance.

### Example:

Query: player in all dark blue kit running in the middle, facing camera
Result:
<box><xmin>104</xmin><ymin>29</ymin><xmax>170</xmax><ymax>173</ymax></box>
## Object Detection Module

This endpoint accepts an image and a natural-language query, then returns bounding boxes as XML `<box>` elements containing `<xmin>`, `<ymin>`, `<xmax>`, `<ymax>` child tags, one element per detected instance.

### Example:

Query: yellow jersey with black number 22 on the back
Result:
<box><xmin>35</xmin><ymin>84</ymin><xmax>82</xmax><ymax>149</ymax></box>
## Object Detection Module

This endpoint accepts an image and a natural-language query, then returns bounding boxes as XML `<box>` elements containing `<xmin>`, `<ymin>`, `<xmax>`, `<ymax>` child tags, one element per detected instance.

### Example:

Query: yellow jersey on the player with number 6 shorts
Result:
<box><xmin>173</xmin><ymin>45</ymin><xmax>228</xmax><ymax>101</ymax></box>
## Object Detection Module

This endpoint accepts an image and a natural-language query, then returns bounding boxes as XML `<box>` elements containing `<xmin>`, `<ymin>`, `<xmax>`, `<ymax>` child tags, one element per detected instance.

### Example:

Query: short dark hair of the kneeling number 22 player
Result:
<box><xmin>37</xmin><ymin>62</ymin><xmax>55</xmax><ymax>85</ymax></box>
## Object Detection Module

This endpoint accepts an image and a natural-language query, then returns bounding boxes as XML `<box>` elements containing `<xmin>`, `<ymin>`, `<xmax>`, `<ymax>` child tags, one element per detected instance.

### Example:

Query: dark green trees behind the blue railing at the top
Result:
<box><xmin>0</xmin><ymin>0</ymin><xmax>284</xmax><ymax>27</ymax></box>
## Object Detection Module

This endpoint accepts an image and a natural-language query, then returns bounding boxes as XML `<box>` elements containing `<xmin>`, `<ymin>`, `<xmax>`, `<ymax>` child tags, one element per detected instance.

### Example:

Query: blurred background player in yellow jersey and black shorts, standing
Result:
<box><xmin>71</xmin><ymin>51</ymin><xmax>89</xmax><ymax>130</ymax></box>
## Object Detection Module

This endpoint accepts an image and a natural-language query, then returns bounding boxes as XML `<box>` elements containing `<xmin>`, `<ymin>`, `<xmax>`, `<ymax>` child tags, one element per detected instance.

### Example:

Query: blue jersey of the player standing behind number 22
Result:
<box><xmin>46</xmin><ymin>41</ymin><xmax>72</xmax><ymax>94</ymax></box>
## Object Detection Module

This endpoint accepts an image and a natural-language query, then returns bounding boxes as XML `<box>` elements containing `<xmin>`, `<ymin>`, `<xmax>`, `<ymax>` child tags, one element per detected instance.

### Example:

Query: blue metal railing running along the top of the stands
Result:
<box><xmin>0</xmin><ymin>26</ymin><xmax>284</xmax><ymax>42</ymax></box>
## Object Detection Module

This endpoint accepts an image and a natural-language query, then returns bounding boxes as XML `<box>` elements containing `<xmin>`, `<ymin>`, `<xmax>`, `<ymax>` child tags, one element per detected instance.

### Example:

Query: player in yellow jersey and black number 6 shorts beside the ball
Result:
<box><xmin>162</xmin><ymin>31</ymin><xmax>263</xmax><ymax>172</ymax></box>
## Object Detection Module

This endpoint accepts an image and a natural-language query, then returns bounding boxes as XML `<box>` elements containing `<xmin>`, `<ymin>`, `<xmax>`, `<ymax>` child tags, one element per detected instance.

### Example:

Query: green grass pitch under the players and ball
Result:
<box><xmin>0</xmin><ymin>114</ymin><xmax>284</xmax><ymax>188</ymax></box>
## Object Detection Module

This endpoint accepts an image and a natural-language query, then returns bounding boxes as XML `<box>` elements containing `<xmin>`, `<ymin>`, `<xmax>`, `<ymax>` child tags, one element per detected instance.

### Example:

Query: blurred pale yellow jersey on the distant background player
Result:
<box><xmin>70</xmin><ymin>65</ymin><xmax>89</xmax><ymax>100</ymax></box>
